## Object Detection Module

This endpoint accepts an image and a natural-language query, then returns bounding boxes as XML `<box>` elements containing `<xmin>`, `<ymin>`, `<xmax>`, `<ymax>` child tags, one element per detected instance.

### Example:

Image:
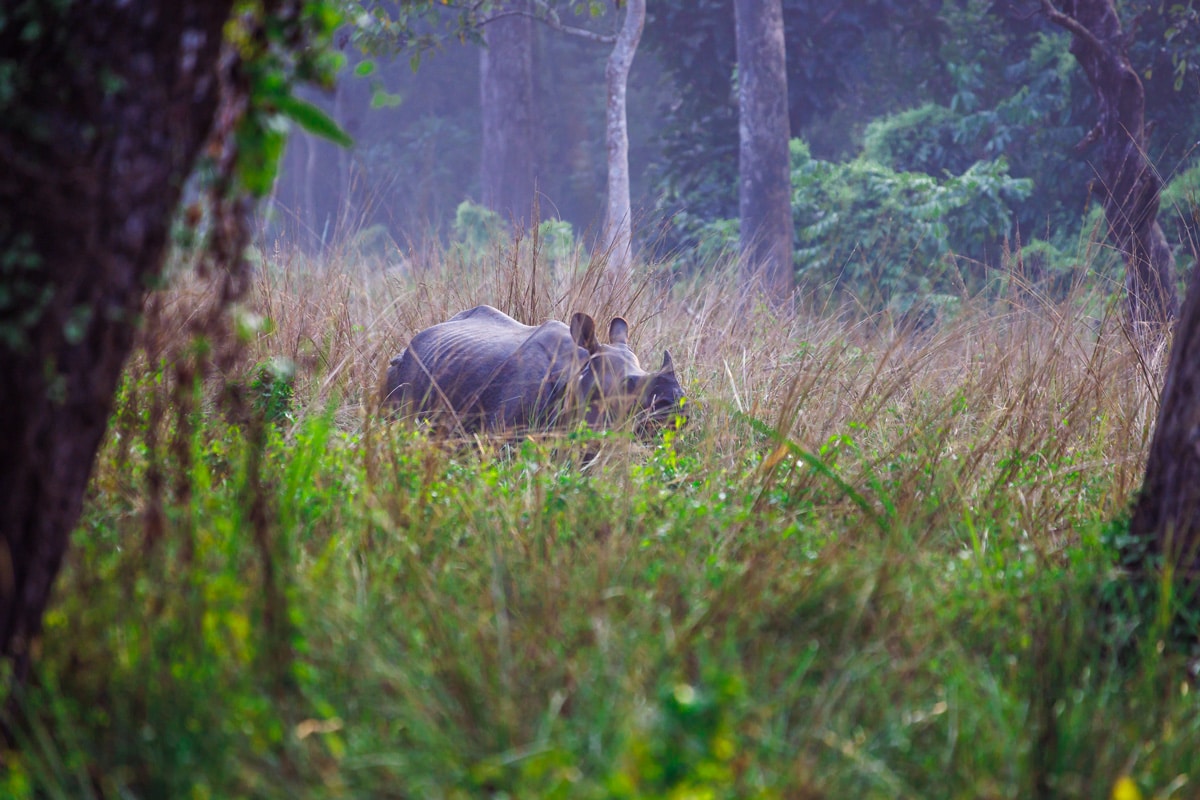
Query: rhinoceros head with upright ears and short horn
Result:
<box><xmin>571</xmin><ymin>313</ymin><xmax>685</xmax><ymax>432</ymax></box>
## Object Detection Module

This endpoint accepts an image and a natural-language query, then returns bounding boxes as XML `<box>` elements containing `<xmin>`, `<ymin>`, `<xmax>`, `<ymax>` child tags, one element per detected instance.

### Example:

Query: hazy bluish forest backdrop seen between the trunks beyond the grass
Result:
<box><xmin>266</xmin><ymin>0</ymin><xmax>1200</xmax><ymax>309</ymax></box>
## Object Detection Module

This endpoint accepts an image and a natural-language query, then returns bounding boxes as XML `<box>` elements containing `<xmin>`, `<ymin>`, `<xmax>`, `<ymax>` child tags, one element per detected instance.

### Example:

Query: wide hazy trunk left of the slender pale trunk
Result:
<box><xmin>479</xmin><ymin>0</ymin><xmax>536</xmax><ymax>225</ymax></box>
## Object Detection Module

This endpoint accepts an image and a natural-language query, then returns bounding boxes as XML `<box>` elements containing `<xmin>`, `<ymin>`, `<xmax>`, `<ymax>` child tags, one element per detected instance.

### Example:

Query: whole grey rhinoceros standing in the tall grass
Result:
<box><xmin>383</xmin><ymin>306</ymin><xmax>684</xmax><ymax>433</ymax></box>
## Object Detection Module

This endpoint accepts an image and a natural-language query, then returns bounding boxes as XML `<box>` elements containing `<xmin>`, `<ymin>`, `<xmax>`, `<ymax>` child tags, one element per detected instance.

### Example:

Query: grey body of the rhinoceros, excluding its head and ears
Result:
<box><xmin>385</xmin><ymin>306</ymin><xmax>587</xmax><ymax>432</ymax></box>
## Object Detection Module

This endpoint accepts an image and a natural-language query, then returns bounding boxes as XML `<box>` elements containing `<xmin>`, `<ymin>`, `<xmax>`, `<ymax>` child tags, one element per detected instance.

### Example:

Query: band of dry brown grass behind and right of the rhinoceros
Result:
<box><xmin>176</xmin><ymin>239</ymin><xmax>1162</xmax><ymax>542</ymax></box>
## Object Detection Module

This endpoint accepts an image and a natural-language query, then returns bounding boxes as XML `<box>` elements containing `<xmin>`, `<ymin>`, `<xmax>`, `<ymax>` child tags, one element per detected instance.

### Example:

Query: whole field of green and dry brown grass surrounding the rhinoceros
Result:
<box><xmin>0</xmin><ymin>241</ymin><xmax>1200</xmax><ymax>798</ymax></box>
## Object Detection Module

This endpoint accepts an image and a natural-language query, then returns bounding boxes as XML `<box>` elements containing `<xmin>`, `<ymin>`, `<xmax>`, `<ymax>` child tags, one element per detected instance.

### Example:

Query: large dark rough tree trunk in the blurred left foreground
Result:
<box><xmin>0</xmin><ymin>0</ymin><xmax>233</xmax><ymax>678</ymax></box>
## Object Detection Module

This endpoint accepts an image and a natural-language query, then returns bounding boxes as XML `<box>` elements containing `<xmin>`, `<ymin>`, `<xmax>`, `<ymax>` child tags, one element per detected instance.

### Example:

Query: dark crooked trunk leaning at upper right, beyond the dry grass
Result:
<box><xmin>1042</xmin><ymin>0</ymin><xmax>1180</xmax><ymax>342</ymax></box>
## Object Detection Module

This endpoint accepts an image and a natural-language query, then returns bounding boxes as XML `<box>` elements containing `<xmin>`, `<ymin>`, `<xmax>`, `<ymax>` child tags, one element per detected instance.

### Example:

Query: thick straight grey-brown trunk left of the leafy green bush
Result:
<box><xmin>733</xmin><ymin>0</ymin><xmax>794</xmax><ymax>303</ymax></box>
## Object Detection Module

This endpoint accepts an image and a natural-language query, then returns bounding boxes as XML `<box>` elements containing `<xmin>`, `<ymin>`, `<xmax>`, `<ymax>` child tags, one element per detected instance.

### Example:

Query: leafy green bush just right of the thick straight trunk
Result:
<box><xmin>792</xmin><ymin>134</ymin><xmax>1031</xmax><ymax>309</ymax></box>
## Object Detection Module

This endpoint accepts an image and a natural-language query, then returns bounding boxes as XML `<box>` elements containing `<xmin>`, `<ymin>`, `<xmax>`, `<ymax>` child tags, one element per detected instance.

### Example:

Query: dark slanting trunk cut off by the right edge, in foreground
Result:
<box><xmin>1129</xmin><ymin>260</ymin><xmax>1200</xmax><ymax>566</ymax></box>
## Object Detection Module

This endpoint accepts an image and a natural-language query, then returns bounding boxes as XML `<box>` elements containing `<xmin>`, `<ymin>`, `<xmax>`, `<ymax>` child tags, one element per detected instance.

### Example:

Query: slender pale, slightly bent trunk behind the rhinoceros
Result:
<box><xmin>604</xmin><ymin>0</ymin><xmax>646</xmax><ymax>288</ymax></box>
